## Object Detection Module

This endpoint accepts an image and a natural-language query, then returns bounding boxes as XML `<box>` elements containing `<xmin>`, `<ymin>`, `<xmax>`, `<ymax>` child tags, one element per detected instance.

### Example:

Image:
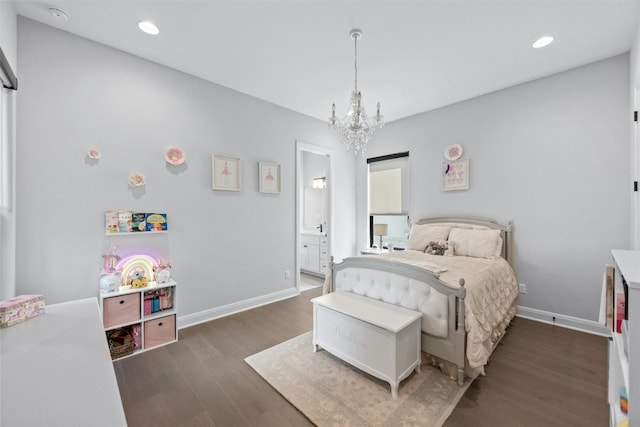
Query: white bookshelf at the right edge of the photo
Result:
<box><xmin>608</xmin><ymin>249</ymin><xmax>640</xmax><ymax>427</ymax></box>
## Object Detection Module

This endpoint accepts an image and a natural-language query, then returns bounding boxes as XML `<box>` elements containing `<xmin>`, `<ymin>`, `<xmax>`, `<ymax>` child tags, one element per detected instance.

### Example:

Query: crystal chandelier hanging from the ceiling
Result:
<box><xmin>329</xmin><ymin>29</ymin><xmax>384</xmax><ymax>156</ymax></box>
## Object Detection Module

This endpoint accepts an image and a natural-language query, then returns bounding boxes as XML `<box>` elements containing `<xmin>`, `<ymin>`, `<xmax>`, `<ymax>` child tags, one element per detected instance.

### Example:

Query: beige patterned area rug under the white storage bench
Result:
<box><xmin>245</xmin><ymin>332</ymin><xmax>471</xmax><ymax>427</ymax></box>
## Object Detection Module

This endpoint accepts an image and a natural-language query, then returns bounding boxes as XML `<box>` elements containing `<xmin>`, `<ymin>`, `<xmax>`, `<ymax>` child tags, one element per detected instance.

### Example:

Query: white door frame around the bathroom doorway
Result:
<box><xmin>295</xmin><ymin>141</ymin><xmax>334</xmax><ymax>293</ymax></box>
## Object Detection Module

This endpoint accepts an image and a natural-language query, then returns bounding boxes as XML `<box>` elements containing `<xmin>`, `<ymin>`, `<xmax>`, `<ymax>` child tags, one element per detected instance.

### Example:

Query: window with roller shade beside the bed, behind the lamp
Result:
<box><xmin>367</xmin><ymin>151</ymin><xmax>410</xmax><ymax>249</ymax></box>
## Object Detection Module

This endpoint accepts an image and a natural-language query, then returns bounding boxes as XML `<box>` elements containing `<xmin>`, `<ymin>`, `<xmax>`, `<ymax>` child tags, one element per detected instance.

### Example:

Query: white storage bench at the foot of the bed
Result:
<box><xmin>311</xmin><ymin>291</ymin><xmax>422</xmax><ymax>398</ymax></box>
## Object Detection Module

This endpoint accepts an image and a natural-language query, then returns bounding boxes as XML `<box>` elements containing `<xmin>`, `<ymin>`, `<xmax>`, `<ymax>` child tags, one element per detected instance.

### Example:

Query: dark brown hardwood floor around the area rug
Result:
<box><xmin>114</xmin><ymin>288</ymin><xmax>608</xmax><ymax>427</ymax></box>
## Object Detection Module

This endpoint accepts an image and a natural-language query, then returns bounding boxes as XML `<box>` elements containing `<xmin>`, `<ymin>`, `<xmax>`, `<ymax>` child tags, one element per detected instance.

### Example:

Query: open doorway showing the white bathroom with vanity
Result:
<box><xmin>295</xmin><ymin>141</ymin><xmax>333</xmax><ymax>292</ymax></box>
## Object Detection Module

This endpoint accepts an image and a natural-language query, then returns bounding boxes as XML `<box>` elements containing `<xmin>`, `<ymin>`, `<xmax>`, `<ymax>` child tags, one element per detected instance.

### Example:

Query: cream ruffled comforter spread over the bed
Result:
<box><xmin>378</xmin><ymin>250</ymin><xmax>518</xmax><ymax>372</ymax></box>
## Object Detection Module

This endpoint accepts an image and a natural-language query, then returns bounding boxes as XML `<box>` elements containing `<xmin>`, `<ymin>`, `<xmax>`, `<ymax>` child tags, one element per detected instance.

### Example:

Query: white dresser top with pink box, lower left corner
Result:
<box><xmin>0</xmin><ymin>298</ymin><xmax>127</xmax><ymax>427</ymax></box>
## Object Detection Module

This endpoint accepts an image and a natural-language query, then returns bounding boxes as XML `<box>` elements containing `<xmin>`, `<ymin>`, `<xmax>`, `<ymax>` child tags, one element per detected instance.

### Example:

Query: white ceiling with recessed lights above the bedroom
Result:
<box><xmin>12</xmin><ymin>0</ymin><xmax>640</xmax><ymax>122</ymax></box>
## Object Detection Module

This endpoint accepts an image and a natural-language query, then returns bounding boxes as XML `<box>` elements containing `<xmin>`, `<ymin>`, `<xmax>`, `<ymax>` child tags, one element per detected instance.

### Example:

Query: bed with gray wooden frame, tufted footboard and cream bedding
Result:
<box><xmin>325</xmin><ymin>217</ymin><xmax>518</xmax><ymax>384</ymax></box>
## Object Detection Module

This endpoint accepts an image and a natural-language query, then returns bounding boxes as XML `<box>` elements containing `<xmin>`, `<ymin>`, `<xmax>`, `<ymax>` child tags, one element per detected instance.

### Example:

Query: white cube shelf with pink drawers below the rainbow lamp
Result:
<box><xmin>100</xmin><ymin>280</ymin><xmax>178</xmax><ymax>360</ymax></box>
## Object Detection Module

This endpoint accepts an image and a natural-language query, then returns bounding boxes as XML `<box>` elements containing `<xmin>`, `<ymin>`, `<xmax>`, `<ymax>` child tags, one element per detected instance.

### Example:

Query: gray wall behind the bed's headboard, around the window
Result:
<box><xmin>358</xmin><ymin>54</ymin><xmax>631</xmax><ymax>320</ymax></box>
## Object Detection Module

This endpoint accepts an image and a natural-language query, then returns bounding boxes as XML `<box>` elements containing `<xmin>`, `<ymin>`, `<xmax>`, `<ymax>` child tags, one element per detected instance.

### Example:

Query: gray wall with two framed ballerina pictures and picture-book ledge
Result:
<box><xmin>17</xmin><ymin>18</ymin><xmax>355</xmax><ymax>315</ymax></box>
